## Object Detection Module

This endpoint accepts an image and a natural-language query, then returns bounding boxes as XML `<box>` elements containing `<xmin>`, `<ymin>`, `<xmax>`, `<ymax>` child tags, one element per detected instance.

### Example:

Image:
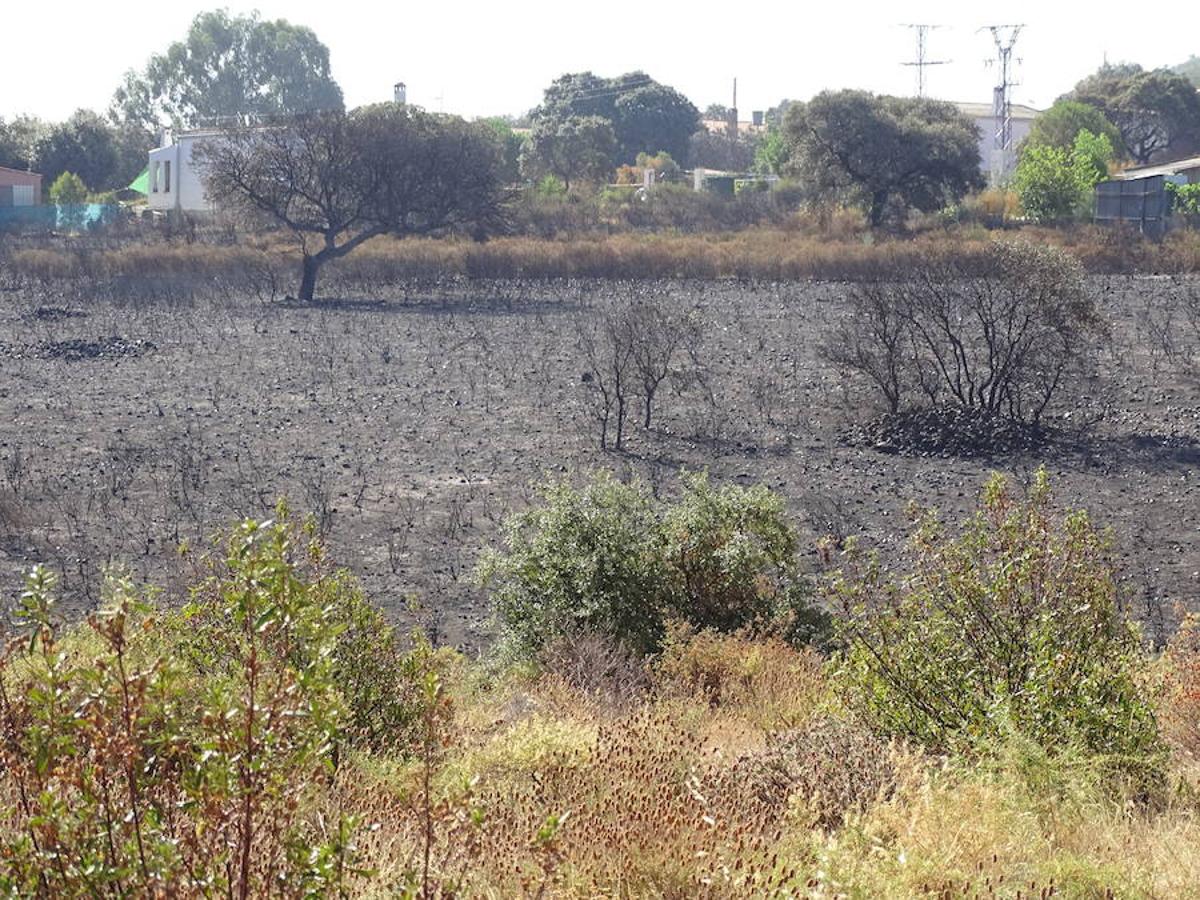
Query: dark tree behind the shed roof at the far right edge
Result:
<box><xmin>1066</xmin><ymin>64</ymin><xmax>1200</xmax><ymax>164</ymax></box>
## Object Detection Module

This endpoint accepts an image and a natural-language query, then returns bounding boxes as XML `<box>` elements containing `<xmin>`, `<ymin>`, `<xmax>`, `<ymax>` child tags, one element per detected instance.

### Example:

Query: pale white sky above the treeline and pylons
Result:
<box><xmin>0</xmin><ymin>0</ymin><xmax>1200</xmax><ymax>120</ymax></box>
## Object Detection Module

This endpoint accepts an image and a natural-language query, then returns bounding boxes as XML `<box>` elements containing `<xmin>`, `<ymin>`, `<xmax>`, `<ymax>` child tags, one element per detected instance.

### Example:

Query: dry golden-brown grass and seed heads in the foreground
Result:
<box><xmin>312</xmin><ymin>634</ymin><xmax>1200</xmax><ymax>898</ymax></box>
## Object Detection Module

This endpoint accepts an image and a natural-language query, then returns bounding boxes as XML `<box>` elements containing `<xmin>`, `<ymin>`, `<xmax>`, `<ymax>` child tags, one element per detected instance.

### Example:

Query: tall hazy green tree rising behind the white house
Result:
<box><xmin>112</xmin><ymin>10</ymin><xmax>342</xmax><ymax>132</ymax></box>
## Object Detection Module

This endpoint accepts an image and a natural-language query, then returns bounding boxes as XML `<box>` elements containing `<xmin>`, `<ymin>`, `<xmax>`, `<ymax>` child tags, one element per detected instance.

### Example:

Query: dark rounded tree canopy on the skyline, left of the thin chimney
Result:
<box><xmin>533</xmin><ymin>72</ymin><xmax>700</xmax><ymax>164</ymax></box>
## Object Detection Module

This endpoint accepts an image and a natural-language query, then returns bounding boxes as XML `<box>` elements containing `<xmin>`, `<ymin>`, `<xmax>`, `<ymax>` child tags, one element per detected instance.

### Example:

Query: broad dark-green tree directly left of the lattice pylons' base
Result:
<box><xmin>784</xmin><ymin>90</ymin><xmax>983</xmax><ymax>227</ymax></box>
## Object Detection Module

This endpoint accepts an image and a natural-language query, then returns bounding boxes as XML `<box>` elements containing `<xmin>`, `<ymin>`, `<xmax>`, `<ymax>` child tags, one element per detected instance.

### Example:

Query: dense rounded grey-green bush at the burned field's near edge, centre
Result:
<box><xmin>479</xmin><ymin>473</ymin><xmax>822</xmax><ymax>656</ymax></box>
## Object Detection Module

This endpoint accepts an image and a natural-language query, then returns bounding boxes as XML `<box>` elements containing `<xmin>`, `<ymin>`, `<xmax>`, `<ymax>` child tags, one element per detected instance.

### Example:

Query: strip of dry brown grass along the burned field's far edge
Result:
<box><xmin>7</xmin><ymin>227</ymin><xmax>1200</xmax><ymax>294</ymax></box>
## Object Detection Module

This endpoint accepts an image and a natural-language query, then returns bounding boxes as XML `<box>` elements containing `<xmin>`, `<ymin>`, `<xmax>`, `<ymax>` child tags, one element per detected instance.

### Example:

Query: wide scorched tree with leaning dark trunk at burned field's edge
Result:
<box><xmin>196</xmin><ymin>103</ymin><xmax>506</xmax><ymax>300</ymax></box>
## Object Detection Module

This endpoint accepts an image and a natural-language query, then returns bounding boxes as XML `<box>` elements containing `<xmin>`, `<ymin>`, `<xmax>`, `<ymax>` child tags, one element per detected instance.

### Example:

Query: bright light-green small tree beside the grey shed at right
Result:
<box><xmin>1013</xmin><ymin>130</ymin><xmax>1112</xmax><ymax>222</ymax></box>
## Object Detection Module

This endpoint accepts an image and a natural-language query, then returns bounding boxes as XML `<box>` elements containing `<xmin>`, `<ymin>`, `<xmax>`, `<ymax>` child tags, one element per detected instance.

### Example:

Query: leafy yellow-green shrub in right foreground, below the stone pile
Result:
<box><xmin>830</xmin><ymin>470</ymin><xmax>1160</xmax><ymax>764</ymax></box>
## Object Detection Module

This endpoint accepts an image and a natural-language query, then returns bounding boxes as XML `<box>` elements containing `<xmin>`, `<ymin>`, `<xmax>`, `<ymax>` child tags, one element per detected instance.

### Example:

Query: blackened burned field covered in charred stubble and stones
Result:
<box><xmin>0</xmin><ymin>276</ymin><xmax>1200</xmax><ymax>646</ymax></box>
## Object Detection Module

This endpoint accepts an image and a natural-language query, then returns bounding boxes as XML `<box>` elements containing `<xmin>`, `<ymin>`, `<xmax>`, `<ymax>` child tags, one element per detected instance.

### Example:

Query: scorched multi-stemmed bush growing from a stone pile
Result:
<box><xmin>824</xmin><ymin>241</ymin><xmax>1106</xmax><ymax>425</ymax></box>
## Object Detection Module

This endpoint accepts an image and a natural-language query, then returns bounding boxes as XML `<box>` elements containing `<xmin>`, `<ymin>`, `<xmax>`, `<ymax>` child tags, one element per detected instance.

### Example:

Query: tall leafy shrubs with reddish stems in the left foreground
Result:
<box><xmin>0</xmin><ymin>521</ymin><xmax>355</xmax><ymax>896</ymax></box>
